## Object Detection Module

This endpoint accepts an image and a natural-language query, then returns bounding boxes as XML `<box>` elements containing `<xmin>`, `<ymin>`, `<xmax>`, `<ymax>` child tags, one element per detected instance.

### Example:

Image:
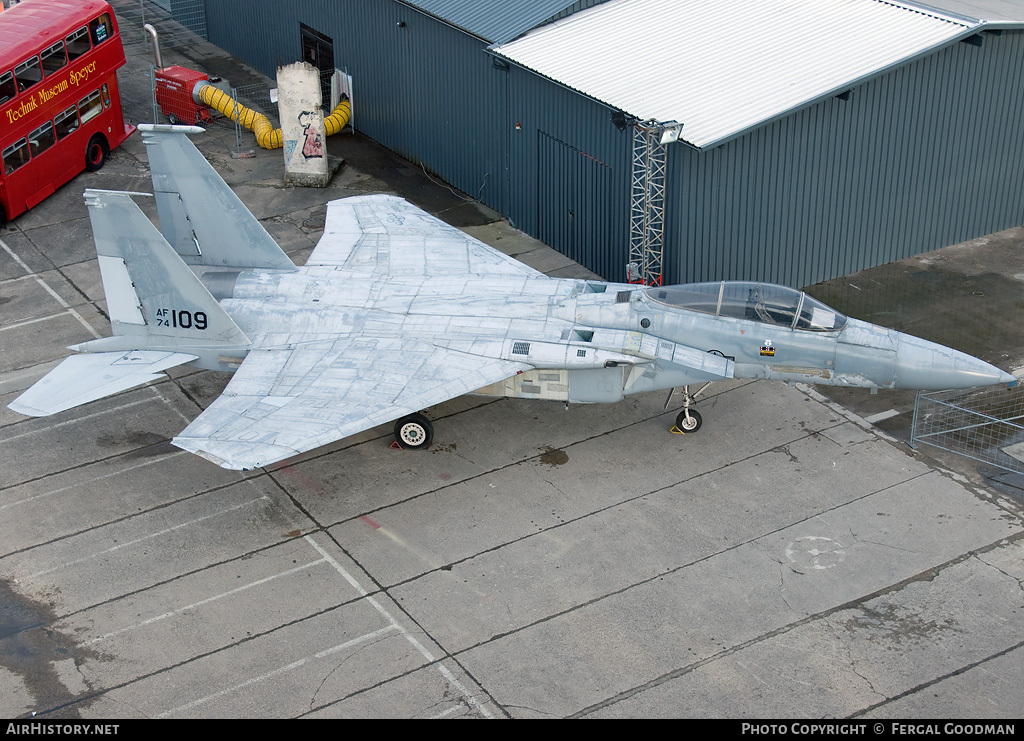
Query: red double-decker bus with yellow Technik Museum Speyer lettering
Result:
<box><xmin>0</xmin><ymin>0</ymin><xmax>135</xmax><ymax>224</ymax></box>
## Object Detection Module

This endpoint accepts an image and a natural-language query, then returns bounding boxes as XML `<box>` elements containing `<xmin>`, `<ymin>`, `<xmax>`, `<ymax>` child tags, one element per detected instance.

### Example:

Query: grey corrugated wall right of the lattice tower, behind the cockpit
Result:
<box><xmin>666</xmin><ymin>32</ymin><xmax>1024</xmax><ymax>286</ymax></box>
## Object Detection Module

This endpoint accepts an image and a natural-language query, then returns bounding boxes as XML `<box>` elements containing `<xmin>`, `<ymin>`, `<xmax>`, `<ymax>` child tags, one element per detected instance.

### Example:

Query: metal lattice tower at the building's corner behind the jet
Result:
<box><xmin>627</xmin><ymin>121</ymin><xmax>667</xmax><ymax>286</ymax></box>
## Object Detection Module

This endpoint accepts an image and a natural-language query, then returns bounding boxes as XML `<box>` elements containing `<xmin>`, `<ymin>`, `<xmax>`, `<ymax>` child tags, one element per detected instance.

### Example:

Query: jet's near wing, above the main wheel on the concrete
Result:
<box><xmin>172</xmin><ymin>338</ymin><xmax>531</xmax><ymax>470</ymax></box>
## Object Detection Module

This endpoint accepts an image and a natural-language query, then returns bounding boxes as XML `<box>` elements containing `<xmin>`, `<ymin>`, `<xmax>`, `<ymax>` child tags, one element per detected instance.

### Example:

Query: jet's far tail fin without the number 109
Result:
<box><xmin>138</xmin><ymin>124</ymin><xmax>295</xmax><ymax>270</ymax></box>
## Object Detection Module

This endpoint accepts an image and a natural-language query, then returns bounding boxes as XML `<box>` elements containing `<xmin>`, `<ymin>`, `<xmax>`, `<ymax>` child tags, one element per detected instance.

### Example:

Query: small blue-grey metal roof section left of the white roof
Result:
<box><xmin>401</xmin><ymin>0</ymin><xmax>589</xmax><ymax>44</ymax></box>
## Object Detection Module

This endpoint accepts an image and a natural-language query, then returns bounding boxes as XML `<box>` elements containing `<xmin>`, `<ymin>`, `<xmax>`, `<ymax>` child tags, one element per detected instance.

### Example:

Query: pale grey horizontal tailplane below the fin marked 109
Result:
<box><xmin>9</xmin><ymin>350</ymin><xmax>198</xmax><ymax>417</ymax></box>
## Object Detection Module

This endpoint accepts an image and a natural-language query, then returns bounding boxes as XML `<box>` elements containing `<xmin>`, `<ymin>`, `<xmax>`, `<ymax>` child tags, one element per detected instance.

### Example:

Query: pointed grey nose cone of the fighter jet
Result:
<box><xmin>896</xmin><ymin>335</ymin><xmax>1017</xmax><ymax>391</ymax></box>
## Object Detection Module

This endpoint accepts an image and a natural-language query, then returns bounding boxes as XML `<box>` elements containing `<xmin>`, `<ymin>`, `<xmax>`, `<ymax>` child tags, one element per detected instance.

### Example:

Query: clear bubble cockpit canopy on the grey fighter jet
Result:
<box><xmin>645</xmin><ymin>280</ymin><xmax>846</xmax><ymax>332</ymax></box>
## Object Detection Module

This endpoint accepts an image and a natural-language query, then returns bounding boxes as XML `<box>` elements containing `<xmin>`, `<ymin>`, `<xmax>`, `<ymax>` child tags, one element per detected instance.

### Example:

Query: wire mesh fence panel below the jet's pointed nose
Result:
<box><xmin>910</xmin><ymin>386</ymin><xmax>1024</xmax><ymax>473</ymax></box>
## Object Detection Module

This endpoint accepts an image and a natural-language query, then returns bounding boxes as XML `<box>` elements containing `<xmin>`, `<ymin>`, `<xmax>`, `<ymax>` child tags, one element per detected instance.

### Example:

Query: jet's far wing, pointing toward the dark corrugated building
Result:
<box><xmin>306</xmin><ymin>194</ymin><xmax>544</xmax><ymax>277</ymax></box>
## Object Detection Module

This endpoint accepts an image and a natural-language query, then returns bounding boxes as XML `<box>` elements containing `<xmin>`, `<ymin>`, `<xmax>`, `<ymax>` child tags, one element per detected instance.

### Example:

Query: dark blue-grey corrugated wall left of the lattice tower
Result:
<box><xmin>206</xmin><ymin>0</ymin><xmax>630</xmax><ymax>276</ymax></box>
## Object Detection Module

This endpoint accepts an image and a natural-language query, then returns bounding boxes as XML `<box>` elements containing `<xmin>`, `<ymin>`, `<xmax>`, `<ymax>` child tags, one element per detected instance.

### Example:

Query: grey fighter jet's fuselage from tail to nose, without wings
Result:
<box><xmin>180</xmin><ymin>267</ymin><xmax>1013</xmax><ymax>402</ymax></box>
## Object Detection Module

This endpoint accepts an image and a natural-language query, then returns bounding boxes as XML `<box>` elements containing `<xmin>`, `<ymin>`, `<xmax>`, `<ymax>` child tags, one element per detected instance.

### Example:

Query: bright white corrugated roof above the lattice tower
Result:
<box><xmin>493</xmin><ymin>0</ymin><xmax>982</xmax><ymax>148</ymax></box>
